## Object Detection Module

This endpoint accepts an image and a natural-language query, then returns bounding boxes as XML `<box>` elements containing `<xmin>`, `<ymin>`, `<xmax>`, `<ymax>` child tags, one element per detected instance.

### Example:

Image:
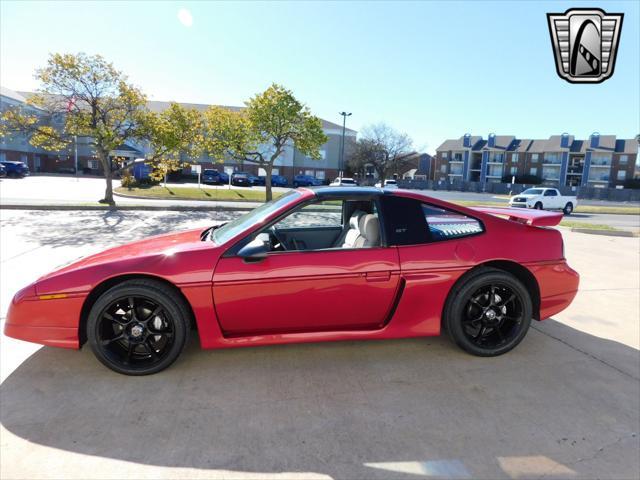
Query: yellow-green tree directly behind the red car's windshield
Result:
<box><xmin>204</xmin><ymin>84</ymin><xmax>327</xmax><ymax>200</ymax></box>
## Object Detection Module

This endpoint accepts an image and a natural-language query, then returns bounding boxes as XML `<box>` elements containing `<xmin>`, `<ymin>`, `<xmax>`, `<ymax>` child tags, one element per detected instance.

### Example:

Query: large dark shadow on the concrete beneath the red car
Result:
<box><xmin>0</xmin><ymin>320</ymin><xmax>640</xmax><ymax>479</ymax></box>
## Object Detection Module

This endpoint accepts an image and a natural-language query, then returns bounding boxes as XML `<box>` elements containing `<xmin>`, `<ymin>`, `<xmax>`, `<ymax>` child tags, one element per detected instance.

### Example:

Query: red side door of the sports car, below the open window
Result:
<box><xmin>213</xmin><ymin>197</ymin><xmax>400</xmax><ymax>336</ymax></box>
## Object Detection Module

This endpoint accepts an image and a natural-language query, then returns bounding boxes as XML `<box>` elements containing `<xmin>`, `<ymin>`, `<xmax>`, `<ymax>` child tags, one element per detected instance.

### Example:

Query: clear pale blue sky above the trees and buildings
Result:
<box><xmin>0</xmin><ymin>0</ymin><xmax>640</xmax><ymax>153</ymax></box>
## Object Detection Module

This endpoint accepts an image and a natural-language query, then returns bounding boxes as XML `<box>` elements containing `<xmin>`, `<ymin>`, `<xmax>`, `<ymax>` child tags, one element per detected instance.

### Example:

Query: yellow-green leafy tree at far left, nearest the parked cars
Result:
<box><xmin>2</xmin><ymin>53</ymin><xmax>146</xmax><ymax>205</ymax></box>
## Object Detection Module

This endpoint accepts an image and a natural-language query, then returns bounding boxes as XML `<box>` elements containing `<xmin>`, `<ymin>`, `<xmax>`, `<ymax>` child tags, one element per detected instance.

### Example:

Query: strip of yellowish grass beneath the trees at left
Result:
<box><xmin>115</xmin><ymin>185</ymin><xmax>282</xmax><ymax>202</ymax></box>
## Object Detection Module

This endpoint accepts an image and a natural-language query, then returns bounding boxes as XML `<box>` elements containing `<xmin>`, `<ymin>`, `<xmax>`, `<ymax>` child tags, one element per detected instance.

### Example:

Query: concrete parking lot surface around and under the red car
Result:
<box><xmin>0</xmin><ymin>210</ymin><xmax>640</xmax><ymax>479</ymax></box>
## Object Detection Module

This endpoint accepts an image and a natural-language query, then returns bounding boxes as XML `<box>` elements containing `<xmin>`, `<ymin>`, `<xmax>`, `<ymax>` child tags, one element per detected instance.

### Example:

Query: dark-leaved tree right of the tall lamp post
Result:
<box><xmin>349</xmin><ymin>123</ymin><xmax>413</xmax><ymax>185</ymax></box>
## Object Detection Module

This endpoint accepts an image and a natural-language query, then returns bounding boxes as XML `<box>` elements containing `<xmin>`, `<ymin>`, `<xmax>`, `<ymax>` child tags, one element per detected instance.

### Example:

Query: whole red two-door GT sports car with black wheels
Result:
<box><xmin>5</xmin><ymin>187</ymin><xmax>578</xmax><ymax>375</ymax></box>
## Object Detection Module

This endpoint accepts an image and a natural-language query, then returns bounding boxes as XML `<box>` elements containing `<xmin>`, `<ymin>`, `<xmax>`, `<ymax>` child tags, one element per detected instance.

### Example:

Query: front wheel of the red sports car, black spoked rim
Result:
<box><xmin>87</xmin><ymin>279</ymin><xmax>191</xmax><ymax>375</ymax></box>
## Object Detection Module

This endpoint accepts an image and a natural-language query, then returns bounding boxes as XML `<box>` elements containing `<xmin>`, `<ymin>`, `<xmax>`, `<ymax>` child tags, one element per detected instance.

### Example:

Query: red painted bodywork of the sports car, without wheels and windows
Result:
<box><xmin>5</xmin><ymin>189</ymin><xmax>579</xmax><ymax>348</ymax></box>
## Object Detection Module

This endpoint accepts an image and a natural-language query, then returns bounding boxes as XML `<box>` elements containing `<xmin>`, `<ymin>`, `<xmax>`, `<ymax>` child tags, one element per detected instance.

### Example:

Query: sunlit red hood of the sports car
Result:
<box><xmin>39</xmin><ymin>228</ymin><xmax>204</xmax><ymax>280</ymax></box>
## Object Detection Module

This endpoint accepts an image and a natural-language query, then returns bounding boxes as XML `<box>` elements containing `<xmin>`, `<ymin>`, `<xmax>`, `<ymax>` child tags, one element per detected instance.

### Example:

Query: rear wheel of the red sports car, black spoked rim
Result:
<box><xmin>442</xmin><ymin>268</ymin><xmax>533</xmax><ymax>357</ymax></box>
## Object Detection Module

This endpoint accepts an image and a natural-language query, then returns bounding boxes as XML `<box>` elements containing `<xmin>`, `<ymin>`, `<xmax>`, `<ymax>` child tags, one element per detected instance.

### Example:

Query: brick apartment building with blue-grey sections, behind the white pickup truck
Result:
<box><xmin>432</xmin><ymin>133</ymin><xmax>638</xmax><ymax>188</ymax></box>
